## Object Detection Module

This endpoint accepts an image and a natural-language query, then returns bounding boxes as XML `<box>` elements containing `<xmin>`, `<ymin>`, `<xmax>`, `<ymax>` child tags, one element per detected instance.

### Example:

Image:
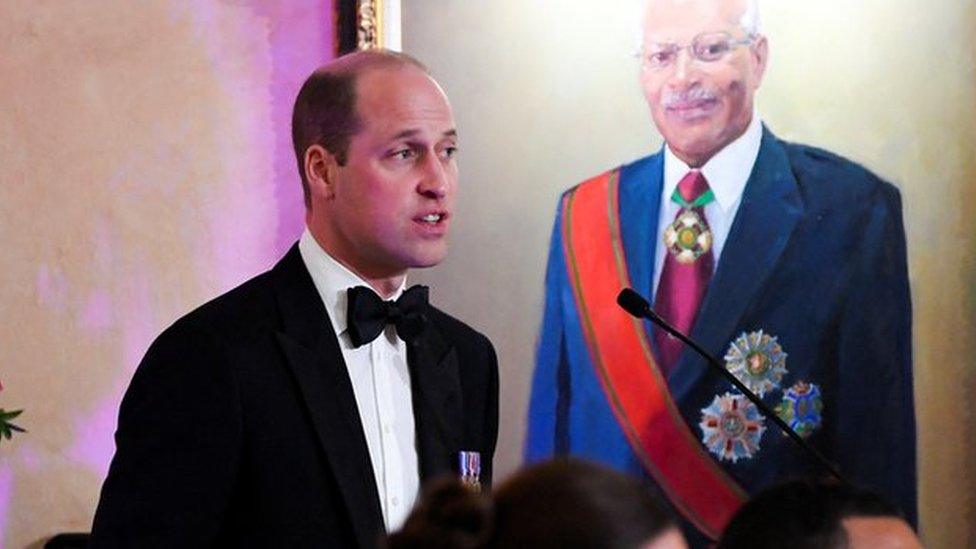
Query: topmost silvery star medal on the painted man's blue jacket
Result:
<box><xmin>725</xmin><ymin>330</ymin><xmax>786</xmax><ymax>397</ymax></box>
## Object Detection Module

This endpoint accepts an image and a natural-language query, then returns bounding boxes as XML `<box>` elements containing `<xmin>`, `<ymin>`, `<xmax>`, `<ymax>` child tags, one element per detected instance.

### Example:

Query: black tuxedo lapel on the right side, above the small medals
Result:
<box><xmin>407</xmin><ymin>321</ymin><xmax>462</xmax><ymax>482</ymax></box>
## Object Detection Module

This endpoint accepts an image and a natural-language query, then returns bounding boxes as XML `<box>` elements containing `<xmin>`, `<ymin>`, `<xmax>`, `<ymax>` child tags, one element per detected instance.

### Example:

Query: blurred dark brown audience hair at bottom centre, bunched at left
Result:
<box><xmin>388</xmin><ymin>460</ymin><xmax>675</xmax><ymax>549</ymax></box>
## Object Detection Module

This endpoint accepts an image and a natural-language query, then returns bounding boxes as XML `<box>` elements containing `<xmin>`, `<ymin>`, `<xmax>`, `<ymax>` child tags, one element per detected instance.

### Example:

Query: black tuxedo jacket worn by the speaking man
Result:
<box><xmin>92</xmin><ymin>246</ymin><xmax>498</xmax><ymax>547</ymax></box>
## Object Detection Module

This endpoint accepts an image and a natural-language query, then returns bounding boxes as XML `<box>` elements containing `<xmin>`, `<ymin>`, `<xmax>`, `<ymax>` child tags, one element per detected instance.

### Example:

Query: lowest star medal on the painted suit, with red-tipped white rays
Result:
<box><xmin>698</xmin><ymin>393</ymin><xmax>766</xmax><ymax>463</ymax></box>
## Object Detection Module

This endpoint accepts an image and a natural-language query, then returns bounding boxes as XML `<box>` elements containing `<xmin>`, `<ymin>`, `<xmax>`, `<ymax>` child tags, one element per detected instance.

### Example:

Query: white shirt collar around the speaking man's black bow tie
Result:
<box><xmin>298</xmin><ymin>227</ymin><xmax>407</xmax><ymax>335</ymax></box>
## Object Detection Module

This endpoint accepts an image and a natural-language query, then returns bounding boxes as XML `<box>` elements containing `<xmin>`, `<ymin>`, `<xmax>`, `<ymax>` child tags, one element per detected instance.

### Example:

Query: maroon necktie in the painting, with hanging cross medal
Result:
<box><xmin>654</xmin><ymin>170</ymin><xmax>715</xmax><ymax>376</ymax></box>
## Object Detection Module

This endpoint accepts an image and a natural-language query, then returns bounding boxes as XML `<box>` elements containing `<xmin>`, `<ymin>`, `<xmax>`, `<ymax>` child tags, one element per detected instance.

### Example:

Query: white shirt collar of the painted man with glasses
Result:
<box><xmin>662</xmin><ymin>112</ymin><xmax>762</xmax><ymax>212</ymax></box>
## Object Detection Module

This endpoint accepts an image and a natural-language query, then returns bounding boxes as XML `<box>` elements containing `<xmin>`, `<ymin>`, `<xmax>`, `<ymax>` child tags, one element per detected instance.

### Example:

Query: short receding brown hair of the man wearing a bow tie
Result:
<box><xmin>291</xmin><ymin>50</ymin><xmax>428</xmax><ymax>208</ymax></box>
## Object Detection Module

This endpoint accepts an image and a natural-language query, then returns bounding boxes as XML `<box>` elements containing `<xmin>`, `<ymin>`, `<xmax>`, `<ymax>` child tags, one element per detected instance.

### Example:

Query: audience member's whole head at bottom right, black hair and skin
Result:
<box><xmin>718</xmin><ymin>480</ymin><xmax>921</xmax><ymax>549</ymax></box>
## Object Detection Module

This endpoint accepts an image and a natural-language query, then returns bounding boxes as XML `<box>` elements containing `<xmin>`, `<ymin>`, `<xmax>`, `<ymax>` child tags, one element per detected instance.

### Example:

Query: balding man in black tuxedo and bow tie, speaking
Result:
<box><xmin>92</xmin><ymin>51</ymin><xmax>498</xmax><ymax>547</ymax></box>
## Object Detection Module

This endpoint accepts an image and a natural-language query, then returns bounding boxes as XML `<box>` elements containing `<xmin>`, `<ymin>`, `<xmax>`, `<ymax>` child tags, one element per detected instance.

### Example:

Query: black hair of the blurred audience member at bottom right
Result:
<box><xmin>717</xmin><ymin>480</ymin><xmax>904</xmax><ymax>549</ymax></box>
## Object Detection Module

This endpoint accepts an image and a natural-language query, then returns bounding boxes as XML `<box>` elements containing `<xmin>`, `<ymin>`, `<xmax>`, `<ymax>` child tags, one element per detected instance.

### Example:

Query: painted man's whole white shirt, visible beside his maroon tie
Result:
<box><xmin>652</xmin><ymin>113</ymin><xmax>762</xmax><ymax>302</ymax></box>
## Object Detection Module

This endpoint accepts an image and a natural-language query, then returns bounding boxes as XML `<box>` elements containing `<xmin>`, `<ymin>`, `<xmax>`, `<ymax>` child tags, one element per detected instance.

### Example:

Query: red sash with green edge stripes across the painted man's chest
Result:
<box><xmin>562</xmin><ymin>171</ymin><xmax>747</xmax><ymax>539</ymax></box>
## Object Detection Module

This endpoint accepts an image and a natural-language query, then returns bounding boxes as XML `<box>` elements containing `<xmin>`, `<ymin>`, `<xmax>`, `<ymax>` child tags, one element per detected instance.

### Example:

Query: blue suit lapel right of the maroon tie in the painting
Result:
<box><xmin>669</xmin><ymin>127</ymin><xmax>803</xmax><ymax>401</ymax></box>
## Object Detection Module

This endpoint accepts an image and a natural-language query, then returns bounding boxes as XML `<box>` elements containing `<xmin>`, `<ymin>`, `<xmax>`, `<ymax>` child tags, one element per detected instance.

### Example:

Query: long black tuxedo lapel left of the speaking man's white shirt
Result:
<box><xmin>272</xmin><ymin>245</ymin><xmax>384</xmax><ymax>547</ymax></box>
